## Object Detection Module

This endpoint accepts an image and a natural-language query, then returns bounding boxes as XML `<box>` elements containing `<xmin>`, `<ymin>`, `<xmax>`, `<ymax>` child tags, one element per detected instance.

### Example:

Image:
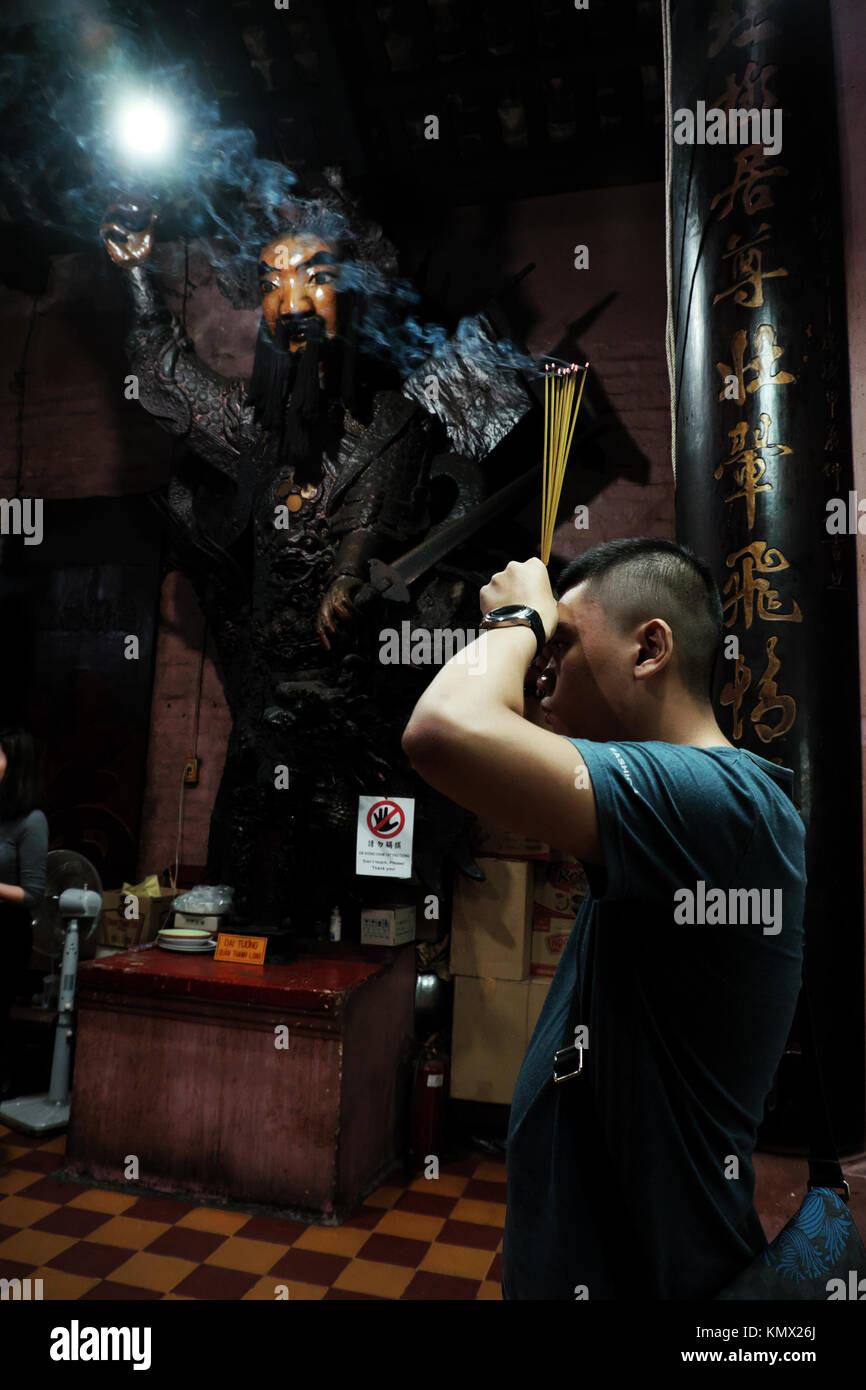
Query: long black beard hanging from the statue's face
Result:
<box><xmin>246</xmin><ymin>320</ymin><xmax>342</xmax><ymax>487</ymax></box>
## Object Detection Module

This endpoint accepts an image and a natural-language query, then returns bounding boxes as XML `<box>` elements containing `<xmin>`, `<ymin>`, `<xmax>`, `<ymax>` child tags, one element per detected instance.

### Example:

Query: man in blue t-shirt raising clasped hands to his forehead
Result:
<box><xmin>403</xmin><ymin>539</ymin><xmax>806</xmax><ymax>1300</ymax></box>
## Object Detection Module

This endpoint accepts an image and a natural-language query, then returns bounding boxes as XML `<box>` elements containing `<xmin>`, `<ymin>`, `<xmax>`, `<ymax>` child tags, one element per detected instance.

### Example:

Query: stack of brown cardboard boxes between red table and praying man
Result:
<box><xmin>450</xmin><ymin>824</ymin><xmax>585</xmax><ymax>1105</ymax></box>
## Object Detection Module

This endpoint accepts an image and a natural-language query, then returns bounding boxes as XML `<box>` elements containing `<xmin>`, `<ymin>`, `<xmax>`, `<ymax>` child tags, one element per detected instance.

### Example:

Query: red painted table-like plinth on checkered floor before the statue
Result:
<box><xmin>65</xmin><ymin>942</ymin><xmax>416</xmax><ymax>1222</ymax></box>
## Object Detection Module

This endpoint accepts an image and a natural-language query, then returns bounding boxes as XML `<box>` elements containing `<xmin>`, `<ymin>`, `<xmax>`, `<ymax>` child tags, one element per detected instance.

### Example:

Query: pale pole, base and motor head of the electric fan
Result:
<box><xmin>0</xmin><ymin>888</ymin><xmax>101</xmax><ymax>1134</ymax></box>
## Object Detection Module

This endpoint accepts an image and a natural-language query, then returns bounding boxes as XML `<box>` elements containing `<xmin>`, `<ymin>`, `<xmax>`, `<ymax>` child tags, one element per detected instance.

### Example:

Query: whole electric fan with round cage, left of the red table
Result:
<box><xmin>0</xmin><ymin>849</ymin><xmax>103</xmax><ymax>1134</ymax></box>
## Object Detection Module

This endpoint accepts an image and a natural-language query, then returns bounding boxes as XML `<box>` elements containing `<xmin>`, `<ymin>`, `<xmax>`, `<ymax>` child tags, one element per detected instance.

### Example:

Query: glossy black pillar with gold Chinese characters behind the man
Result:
<box><xmin>671</xmin><ymin>0</ymin><xmax>866</xmax><ymax>1152</ymax></box>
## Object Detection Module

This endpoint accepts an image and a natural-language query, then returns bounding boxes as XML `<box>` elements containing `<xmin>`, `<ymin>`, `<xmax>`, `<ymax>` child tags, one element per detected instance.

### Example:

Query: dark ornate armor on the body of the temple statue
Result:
<box><xmin>120</xmin><ymin>267</ymin><xmax>528</xmax><ymax>930</ymax></box>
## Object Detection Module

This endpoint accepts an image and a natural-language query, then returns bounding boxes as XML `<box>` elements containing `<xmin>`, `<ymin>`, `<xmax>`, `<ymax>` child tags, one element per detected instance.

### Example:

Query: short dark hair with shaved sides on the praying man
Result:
<box><xmin>556</xmin><ymin>537</ymin><xmax>724</xmax><ymax>701</ymax></box>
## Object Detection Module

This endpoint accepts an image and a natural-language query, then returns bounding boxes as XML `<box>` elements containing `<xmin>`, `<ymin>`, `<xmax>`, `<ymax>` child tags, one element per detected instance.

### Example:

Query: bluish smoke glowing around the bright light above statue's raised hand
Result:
<box><xmin>0</xmin><ymin>7</ymin><xmax>297</xmax><ymax>253</ymax></box>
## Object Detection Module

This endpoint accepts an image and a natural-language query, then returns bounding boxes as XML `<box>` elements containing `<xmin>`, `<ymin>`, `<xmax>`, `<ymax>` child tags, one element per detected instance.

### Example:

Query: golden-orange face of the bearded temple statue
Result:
<box><xmin>259</xmin><ymin>236</ymin><xmax>338</xmax><ymax>353</ymax></box>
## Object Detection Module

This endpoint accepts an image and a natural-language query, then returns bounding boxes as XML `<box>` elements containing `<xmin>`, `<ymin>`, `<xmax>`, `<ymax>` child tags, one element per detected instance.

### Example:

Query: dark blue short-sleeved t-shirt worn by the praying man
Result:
<box><xmin>502</xmin><ymin>738</ymin><xmax>806</xmax><ymax>1300</ymax></box>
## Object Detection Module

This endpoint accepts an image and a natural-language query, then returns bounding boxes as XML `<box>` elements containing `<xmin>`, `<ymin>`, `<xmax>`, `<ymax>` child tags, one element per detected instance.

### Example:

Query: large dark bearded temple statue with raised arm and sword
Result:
<box><xmin>101</xmin><ymin>179</ymin><xmax>531</xmax><ymax>951</ymax></box>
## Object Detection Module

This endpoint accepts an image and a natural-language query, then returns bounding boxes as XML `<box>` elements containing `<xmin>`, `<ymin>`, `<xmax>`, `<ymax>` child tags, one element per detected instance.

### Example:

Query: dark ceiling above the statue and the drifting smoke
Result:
<box><xmin>0</xmin><ymin>0</ymin><xmax>663</xmax><ymax>289</ymax></box>
